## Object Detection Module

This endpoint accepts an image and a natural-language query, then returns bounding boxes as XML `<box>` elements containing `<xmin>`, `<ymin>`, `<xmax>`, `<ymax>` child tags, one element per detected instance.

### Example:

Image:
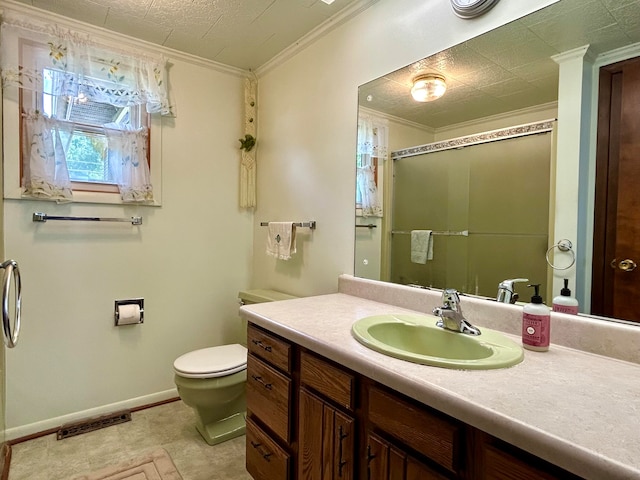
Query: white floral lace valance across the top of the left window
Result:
<box><xmin>0</xmin><ymin>18</ymin><xmax>172</xmax><ymax>115</ymax></box>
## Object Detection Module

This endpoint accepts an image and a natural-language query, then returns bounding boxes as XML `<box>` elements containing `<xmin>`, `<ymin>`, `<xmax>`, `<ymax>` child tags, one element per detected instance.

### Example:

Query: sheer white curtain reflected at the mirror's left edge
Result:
<box><xmin>356</xmin><ymin>115</ymin><xmax>389</xmax><ymax>217</ymax></box>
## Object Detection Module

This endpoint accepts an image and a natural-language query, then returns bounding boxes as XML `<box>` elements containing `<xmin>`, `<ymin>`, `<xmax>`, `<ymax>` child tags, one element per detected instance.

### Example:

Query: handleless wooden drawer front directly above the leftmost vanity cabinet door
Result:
<box><xmin>300</xmin><ymin>352</ymin><xmax>355</xmax><ymax>410</ymax></box>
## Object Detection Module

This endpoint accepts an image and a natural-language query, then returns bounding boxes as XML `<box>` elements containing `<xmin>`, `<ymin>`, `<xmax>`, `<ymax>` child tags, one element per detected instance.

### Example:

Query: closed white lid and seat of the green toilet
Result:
<box><xmin>173</xmin><ymin>344</ymin><xmax>247</xmax><ymax>378</ymax></box>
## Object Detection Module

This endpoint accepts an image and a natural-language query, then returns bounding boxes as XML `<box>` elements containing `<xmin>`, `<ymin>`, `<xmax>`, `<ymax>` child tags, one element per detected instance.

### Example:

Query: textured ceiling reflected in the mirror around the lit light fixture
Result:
<box><xmin>359</xmin><ymin>0</ymin><xmax>640</xmax><ymax>129</ymax></box>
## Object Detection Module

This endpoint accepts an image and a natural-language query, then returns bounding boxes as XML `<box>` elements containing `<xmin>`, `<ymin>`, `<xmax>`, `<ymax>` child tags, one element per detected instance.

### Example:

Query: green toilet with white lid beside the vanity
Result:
<box><xmin>173</xmin><ymin>290</ymin><xmax>296</xmax><ymax>445</ymax></box>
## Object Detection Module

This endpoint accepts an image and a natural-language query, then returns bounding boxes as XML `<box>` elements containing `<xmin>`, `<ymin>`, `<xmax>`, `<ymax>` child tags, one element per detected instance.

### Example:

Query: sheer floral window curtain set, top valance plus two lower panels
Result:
<box><xmin>0</xmin><ymin>17</ymin><xmax>174</xmax><ymax>203</ymax></box>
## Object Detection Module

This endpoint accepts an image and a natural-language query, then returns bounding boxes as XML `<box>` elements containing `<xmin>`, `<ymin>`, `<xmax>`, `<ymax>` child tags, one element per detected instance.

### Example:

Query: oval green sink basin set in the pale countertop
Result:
<box><xmin>351</xmin><ymin>314</ymin><xmax>524</xmax><ymax>370</ymax></box>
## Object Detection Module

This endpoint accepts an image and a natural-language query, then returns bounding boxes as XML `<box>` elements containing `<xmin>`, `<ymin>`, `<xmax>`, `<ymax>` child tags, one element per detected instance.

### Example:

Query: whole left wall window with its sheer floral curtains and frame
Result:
<box><xmin>0</xmin><ymin>20</ymin><xmax>173</xmax><ymax>204</ymax></box>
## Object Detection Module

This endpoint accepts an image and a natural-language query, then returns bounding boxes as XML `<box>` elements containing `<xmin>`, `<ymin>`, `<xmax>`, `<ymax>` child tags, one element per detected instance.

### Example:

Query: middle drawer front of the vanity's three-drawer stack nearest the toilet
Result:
<box><xmin>247</xmin><ymin>355</ymin><xmax>291</xmax><ymax>443</ymax></box>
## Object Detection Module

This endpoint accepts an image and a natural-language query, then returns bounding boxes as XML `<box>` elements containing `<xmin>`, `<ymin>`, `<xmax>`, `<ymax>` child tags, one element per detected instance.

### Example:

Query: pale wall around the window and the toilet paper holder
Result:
<box><xmin>4</xmin><ymin>13</ymin><xmax>253</xmax><ymax>438</ymax></box>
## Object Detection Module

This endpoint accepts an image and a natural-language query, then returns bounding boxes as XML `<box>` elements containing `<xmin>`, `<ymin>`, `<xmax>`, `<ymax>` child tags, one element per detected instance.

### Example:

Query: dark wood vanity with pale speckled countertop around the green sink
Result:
<box><xmin>241</xmin><ymin>276</ymin><xmax>640</xmax><ymax>480</ymax></box>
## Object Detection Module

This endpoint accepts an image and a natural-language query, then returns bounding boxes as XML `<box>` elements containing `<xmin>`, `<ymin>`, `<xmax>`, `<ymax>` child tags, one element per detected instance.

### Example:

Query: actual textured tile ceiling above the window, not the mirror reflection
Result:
<box><xmin>11</xmin><ymin>0</ymin><xmax>366</xmax><ymax>70</ymax></box>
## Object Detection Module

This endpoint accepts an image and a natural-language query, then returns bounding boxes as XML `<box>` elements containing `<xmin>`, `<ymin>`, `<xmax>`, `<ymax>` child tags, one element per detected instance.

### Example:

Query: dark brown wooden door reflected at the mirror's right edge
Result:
<box><xmin>591</xmin><ymin>58</ymin><xmax>640</xmax><ymax>322</ymax></box>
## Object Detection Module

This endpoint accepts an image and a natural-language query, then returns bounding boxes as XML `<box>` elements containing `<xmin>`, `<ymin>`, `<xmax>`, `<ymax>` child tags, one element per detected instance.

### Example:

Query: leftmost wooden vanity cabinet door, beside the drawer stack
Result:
<box><xmin>298</xmin><ymin>388</ymin><xmax>355</xmax><ymax>480</ymax></box>
